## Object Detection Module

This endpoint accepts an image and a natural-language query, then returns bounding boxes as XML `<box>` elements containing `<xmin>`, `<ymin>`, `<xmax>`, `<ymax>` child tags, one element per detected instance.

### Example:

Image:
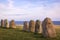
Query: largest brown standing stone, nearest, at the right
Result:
<box><xmin>42</xmin><ymin>18</ymin><xmax>56</xmax><ymax>38</ymax></box>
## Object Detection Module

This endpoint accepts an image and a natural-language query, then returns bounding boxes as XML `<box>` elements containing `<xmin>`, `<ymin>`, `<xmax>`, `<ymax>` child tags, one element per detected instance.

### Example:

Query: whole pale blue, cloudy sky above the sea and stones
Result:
<box><xmin>0</xmin><ymin>0</ymin><xmax>60</xmax><ymax>21</ymax></box>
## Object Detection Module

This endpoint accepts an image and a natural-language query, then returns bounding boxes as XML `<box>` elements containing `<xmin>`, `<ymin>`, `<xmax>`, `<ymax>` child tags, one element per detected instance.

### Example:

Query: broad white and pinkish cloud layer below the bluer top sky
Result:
<box><xmin>0</xmin><ymin>0</ymin><xmax>60</xmax><ymax>20</ymax></box>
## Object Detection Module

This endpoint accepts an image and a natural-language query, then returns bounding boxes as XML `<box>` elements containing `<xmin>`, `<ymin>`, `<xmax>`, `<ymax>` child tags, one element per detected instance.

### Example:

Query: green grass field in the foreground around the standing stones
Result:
<box><xmin>0</xmin><ymin>27</ymin><xmax>60</xmax><ymax>40</ymax></box>
